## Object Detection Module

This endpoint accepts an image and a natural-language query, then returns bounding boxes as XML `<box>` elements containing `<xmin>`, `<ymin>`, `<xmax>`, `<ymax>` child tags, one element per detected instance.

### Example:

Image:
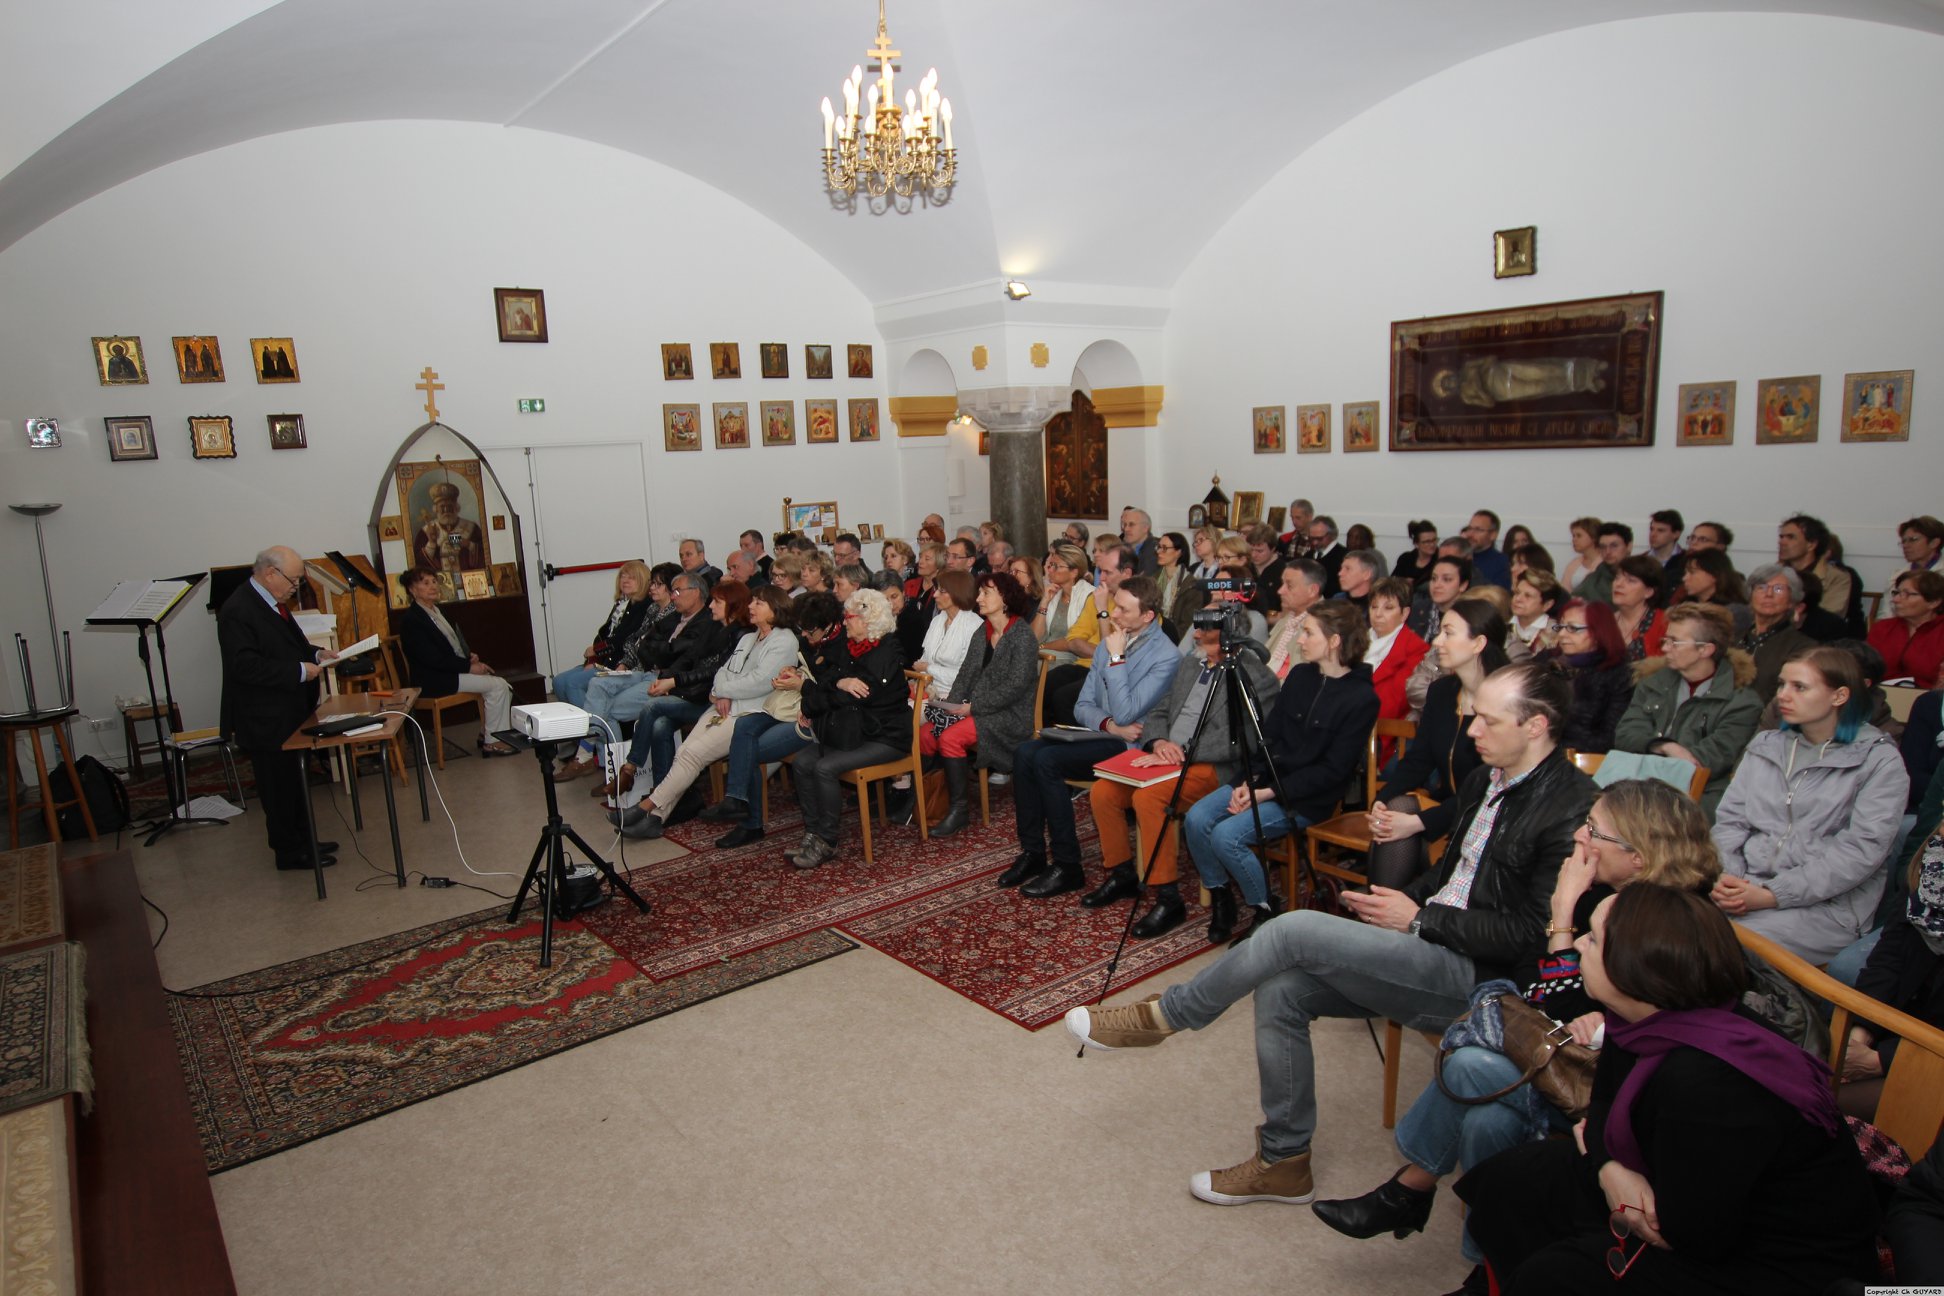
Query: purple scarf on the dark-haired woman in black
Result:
<box><xmin>1604</xmin><ymin>1008</ymin><xmax>1841</xmax><ymax>1176</ymax></box>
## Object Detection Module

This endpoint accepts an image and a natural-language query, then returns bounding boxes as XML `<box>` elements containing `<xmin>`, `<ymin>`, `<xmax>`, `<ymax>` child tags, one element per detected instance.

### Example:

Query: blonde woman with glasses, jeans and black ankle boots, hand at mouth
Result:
<box><xmin>1314</xmin><ymin>779</ymin><xmax>1720</xmax><ymax>1290</ymax></box>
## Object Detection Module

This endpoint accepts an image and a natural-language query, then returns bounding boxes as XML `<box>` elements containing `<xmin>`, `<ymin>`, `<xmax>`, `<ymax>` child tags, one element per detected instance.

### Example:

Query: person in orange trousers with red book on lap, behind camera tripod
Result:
<box><xmin>1081</xmin><ymin>628</ymin><xmax>1281</xmax><ymax>940</ymax></box>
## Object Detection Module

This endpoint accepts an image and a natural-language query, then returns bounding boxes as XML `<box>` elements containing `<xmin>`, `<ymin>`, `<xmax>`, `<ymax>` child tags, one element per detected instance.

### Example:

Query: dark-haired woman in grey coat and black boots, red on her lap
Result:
<box><xmin>918</xmin><ymin>571</ymin><xmax>1040</xmax><ymax>837</ymax></box>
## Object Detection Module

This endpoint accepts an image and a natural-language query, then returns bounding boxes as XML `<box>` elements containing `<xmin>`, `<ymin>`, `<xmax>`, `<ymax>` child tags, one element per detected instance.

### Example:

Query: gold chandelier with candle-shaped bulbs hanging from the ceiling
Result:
<box><xmin>824</xmin><ymin>0</ymin><xmax>958</xmax><ymax>200</ymax></box>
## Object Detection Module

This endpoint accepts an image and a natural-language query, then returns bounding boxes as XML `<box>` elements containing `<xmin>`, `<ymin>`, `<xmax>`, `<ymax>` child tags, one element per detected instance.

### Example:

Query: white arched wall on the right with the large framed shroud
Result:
<box><xmin>1157</xmin><ymin>14</ymin><xmax>1944</xmax><ymax>589</ymax></box>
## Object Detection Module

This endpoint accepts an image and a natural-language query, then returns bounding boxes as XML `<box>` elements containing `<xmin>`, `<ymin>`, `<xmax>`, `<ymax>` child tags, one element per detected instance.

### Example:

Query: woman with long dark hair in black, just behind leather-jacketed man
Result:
<box><xmin>1367</xmin><ymin>598</ymin><xmax>1508</xmax><ymax>886</ymax></box>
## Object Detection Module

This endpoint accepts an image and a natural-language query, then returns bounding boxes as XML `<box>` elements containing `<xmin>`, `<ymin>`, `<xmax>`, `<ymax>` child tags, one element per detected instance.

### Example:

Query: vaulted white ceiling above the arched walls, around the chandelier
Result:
<box><xmin>0</xmin><ymin>0</ymin><xmax>1944</xmax><ymax>303</ymax></box>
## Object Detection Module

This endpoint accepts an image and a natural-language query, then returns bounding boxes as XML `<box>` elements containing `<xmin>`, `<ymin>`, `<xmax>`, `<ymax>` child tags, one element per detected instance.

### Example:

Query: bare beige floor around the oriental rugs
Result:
<box><xmin>110</xmin><ymin>733</ymin><xmax>1468</xmax><ymax>1296</ymax></box>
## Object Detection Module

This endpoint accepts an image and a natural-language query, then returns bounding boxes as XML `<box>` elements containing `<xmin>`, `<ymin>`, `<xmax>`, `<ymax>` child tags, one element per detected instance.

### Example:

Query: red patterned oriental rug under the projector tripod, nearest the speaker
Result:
<box><xmin>169</xmin><ymin>902</ymin><xmax>857</xmax><ymax>1174</ymax></box>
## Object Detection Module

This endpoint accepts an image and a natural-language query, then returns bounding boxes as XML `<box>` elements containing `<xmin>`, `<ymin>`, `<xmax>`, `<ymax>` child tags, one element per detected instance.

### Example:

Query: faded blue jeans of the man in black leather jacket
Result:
<box><xmin>1161</xmin><ymin>909</ymin><xmax>1477</xmax><ymax>1162</ymax></box>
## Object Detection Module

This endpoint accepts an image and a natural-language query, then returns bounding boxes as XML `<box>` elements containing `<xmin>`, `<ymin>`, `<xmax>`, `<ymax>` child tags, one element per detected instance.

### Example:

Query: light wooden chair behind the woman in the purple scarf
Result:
<box><xmin>1734</xmin><ymin>923</ymin><xmax>1944</xmax><ymax>1160</ymax></box>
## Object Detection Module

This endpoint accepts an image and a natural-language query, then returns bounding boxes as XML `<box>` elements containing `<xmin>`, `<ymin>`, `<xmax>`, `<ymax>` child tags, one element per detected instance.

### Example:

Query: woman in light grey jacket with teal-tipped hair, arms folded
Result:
<box><xmin>1715</xmin><ymin>647</ymin><xmax>1909</xmax><ymax>964</ymax></box>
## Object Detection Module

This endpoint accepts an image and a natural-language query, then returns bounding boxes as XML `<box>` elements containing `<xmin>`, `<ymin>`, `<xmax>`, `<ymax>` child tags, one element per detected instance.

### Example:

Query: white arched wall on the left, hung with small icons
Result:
<box><xmin>0</xmin><ymin>122</ymin><xmax>890</xmax><ymax>750</ymax></box>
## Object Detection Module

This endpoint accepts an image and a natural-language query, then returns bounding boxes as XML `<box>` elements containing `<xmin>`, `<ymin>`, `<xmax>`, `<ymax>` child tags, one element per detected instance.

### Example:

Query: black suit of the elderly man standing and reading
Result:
<box><xmin>216</xmin><ymin>581</ymin><xmax>319</xmax><ymax>867</ymax></box>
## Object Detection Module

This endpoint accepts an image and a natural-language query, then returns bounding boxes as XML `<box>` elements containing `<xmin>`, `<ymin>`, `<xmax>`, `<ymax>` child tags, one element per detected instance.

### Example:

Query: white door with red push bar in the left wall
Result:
<box><xmin>488</xmin><ymin>443</ymin><xmax>647</xmax><ymax>678</ymax></box>
